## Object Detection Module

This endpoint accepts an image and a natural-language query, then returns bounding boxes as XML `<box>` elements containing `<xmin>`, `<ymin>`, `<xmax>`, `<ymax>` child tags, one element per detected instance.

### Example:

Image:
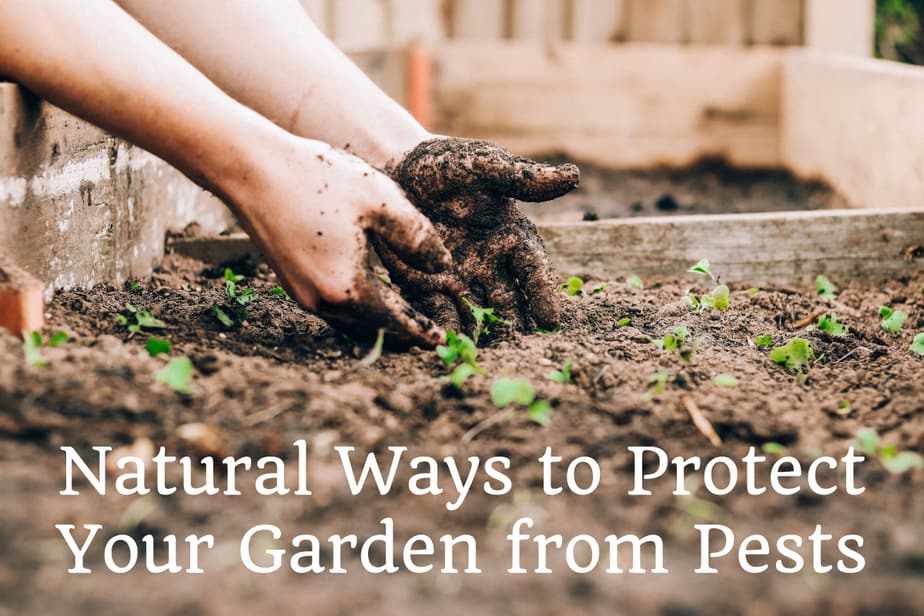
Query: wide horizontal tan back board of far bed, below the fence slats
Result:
<box><xmin>433</xmin><ymin>43</ymin><xmax>782</xmax><ymax>168</ymax></box>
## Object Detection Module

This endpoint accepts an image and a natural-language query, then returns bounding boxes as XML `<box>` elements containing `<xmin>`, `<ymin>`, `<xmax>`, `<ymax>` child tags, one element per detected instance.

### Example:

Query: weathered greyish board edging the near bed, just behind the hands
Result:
<box><xmin>170</xmin><ymin>209</ymin><xmax>924</xmax><ymax>285</ymax></box>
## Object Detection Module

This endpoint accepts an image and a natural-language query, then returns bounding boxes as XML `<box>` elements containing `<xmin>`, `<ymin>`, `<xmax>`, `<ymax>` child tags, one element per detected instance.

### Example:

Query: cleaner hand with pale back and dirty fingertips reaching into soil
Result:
<box><xmin>234</xmin><ymin>139</ymin><xmax>451</xmax><ymax>346</ymax></box>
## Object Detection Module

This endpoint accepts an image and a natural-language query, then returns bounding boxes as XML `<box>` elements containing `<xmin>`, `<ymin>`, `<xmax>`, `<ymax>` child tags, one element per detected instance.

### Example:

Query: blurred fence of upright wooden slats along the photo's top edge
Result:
<box><xmin>302</xmin><ymin>0</ymin><xmax>874</xmax><ymax>55</ymax></box>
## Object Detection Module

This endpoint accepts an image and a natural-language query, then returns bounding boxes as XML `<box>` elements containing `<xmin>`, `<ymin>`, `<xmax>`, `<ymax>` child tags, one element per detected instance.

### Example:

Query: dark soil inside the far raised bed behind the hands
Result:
<box><xmin>524</xmin><ymin>160</ymin><xmax>847</xmax><ymax>222</ymax></box>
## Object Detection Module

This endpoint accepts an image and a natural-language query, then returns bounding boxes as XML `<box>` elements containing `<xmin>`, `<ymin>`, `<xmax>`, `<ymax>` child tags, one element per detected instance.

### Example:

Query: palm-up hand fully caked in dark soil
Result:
<box><xmin>376</xmin><ymin>138</ymin><xmax>580</xmax><ymax>331</ymax></box>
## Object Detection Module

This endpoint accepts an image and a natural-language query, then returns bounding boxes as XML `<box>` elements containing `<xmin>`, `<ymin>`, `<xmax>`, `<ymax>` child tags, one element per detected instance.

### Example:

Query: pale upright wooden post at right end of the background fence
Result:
<box><xmin>805</xmin><ymin>0</ymin><xmax>876</xmax><ymax>57</ymax></box>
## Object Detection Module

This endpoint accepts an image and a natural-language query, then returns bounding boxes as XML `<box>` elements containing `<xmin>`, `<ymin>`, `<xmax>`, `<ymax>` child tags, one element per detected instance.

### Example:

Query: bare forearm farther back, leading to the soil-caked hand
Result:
<box><xmin>117</xmin><ymin>0</ymin><xmax>429</xmax><ymax>168</ymax></box>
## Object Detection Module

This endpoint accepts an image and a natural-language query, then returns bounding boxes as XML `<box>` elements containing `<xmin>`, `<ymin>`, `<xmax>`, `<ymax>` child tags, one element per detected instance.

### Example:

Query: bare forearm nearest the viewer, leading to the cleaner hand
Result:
<box><xmin>0</xmin><ymin>0</ymin><xmax>284</xmax><ymax>207</ymax></box>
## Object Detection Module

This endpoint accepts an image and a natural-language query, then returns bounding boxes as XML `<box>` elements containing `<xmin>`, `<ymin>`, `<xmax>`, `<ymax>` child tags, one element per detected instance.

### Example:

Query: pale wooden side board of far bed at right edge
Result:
<box><xmin>782</xmin><ymin>50</ymin><xmax>924</xmax><ymax>208</ymax></box>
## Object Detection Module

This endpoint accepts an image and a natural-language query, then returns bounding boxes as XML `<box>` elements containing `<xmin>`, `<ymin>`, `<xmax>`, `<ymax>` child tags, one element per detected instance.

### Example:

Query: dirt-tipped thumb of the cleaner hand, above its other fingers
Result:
<box><xmin>369</xmin><ymin>198</ymin><xmax>452</xmax><ymax>273</ymax></box>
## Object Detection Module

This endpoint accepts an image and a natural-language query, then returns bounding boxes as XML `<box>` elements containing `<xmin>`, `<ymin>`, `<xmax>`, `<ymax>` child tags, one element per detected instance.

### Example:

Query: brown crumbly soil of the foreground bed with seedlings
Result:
<box><xmin>0</xmin><ymin>251</ymin><xmax>924</xmax><ymax>616</ymax></box>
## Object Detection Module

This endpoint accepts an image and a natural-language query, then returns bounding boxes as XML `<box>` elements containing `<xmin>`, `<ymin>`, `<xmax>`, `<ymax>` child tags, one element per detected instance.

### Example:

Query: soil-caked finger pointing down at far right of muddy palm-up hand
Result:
<box><xmin>511</xmin><ymin>223</ymin><xmax>561</xmax><ymax>330</ymax></box>
